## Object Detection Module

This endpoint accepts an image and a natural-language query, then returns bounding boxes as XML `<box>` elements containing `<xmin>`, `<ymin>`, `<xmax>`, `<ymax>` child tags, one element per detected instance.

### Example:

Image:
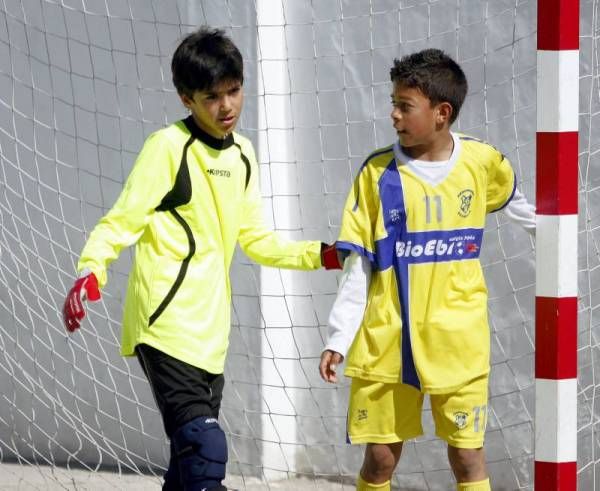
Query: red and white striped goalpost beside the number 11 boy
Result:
<box><xmin>535</xmin><ymin>0</ymin><xmax>579</xmax><ymax>491</ymax></box>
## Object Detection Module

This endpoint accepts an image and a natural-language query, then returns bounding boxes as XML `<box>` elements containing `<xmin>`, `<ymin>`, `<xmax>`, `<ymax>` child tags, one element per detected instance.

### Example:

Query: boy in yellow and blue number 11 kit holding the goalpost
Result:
<box><xmin>319</xmin><ymin>49</ymin><xmax>535</xmax><ymax>491</ymax></box>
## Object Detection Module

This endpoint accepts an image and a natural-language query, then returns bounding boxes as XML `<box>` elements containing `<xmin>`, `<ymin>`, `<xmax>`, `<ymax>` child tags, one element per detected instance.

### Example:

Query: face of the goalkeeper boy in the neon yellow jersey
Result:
<box><xmin>180</xmin><ymin>80</ymin><xmax>244</xmax><ymax>138</ymax></box>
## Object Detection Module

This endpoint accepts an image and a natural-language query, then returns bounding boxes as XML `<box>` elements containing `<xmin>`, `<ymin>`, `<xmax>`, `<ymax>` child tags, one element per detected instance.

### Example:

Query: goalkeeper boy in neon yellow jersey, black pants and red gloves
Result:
<box><xmin>63</xmin><ymin>28</ymin><xmax>337</xmax><ymax>491</ymax></box>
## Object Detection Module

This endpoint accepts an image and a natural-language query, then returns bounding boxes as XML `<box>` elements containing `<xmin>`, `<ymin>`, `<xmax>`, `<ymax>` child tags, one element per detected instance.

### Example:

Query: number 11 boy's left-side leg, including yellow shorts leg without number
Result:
<box><xmin>347</xmin><ymin>378</ymin><xmax>423</xmax><ymax>491</ymax></box>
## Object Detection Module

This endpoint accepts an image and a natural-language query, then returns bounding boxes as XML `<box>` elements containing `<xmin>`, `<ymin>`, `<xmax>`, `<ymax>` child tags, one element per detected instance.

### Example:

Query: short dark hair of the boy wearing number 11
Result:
<box><xmin>390</xmin><ymin>49</ymin><xmax>468</xmax><ymax>124</ymax></box>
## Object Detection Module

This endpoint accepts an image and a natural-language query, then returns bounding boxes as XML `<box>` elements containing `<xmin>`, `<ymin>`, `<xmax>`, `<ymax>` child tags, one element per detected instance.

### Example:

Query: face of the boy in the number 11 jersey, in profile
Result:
<box><xmin>391</xmin><ymin>83</ymin><xmax>452</xmax><ymax>150</ymax></box>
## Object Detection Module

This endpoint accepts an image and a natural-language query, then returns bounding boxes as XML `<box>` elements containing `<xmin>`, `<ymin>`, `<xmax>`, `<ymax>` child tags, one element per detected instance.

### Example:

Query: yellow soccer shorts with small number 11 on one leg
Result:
<box><xmin>347</xmin><ymin>374</ymin><xmax>488</xmax><ymax>448</ymax></box>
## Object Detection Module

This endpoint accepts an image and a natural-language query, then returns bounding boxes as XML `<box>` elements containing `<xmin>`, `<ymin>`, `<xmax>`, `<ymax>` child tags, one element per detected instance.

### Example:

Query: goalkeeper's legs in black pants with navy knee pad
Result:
<box><xmin>136</xmin><ymin>345</ymin><xmax>227</xmax><ymax>491</ymax></box>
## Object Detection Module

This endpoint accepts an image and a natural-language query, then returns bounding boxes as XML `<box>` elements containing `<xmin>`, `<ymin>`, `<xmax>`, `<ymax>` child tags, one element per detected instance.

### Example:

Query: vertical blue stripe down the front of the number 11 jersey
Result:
<box><xmin>376</xmin><ymin>159</ymin><xmax>421</xmax><ymax>390</ymax></box>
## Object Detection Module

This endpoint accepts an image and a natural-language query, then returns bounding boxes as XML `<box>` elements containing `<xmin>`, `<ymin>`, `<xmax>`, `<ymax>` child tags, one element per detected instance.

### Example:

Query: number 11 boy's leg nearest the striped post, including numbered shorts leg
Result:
<box><xmin>431</xmin><ymin>374</ymin><xmax>491</xmax><ymax>491</ymax></box>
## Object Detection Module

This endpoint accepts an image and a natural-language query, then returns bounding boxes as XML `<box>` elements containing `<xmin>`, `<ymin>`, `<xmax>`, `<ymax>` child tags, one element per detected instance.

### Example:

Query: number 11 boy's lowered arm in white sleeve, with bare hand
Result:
<box><xmin>319</xmin><ymin>252</ymin><xmax>371</xmax><ymax>383</ymax></box>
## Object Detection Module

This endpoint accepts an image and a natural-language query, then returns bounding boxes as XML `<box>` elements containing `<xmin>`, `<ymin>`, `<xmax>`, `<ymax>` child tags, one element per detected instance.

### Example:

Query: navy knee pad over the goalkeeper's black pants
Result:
<box><xmin>171</xmin><ymin>416</ymin><xmax>227</xmax><ymax>491</ymax></box>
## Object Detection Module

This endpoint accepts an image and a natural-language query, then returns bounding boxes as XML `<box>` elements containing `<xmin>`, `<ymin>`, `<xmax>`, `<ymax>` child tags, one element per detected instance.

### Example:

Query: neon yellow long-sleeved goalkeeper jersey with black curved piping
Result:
<box><xmin>78</xmin><ymin>116</ymin><xmax>321</xmax><ymax>373</ymax></box>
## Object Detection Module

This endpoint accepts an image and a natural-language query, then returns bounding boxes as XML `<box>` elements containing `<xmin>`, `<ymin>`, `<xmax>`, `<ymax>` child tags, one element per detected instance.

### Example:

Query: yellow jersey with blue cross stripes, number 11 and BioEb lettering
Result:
<box><xmin>337</xmin><ymin>135</ymin><xmax>515</xmax><ymax>393</ymax></box>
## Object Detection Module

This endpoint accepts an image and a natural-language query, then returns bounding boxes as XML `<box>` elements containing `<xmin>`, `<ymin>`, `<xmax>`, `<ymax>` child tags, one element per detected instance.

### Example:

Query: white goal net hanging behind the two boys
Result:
<box><xmin>0</xmin><ymin>0</ymin><xmax>600</xmax><ymax>490</ymax></box>
